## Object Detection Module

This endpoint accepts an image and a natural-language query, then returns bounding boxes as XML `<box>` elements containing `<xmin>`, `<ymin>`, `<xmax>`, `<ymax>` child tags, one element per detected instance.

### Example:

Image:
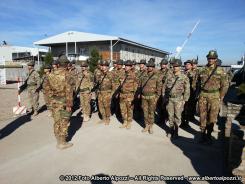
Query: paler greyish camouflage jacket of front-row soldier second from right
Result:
<box><xmin>165</xmin><ymin>73</ymin><xmax>190</xmax><ymax>101</ymax></box>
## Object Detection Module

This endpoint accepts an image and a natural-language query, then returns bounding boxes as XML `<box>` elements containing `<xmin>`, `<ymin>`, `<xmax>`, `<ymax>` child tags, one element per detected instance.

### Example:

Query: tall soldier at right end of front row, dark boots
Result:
<box><xmin>198</xmin><ymin>50</ymin><xmax>228</xmax><ymax>144</ymax></box>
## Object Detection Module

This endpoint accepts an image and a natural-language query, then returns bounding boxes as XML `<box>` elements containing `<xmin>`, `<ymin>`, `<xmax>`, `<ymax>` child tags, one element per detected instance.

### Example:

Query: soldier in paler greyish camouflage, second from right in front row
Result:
<box><xmin>165</xmin><ymin>59</ymin><xmax>190</xmax><ymax>139</ymax></box>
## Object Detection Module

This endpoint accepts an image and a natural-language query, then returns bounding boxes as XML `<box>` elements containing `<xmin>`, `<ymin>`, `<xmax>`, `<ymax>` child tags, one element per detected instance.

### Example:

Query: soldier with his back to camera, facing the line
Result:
<box><xmin>47</xmin><ymin>55</ymin><xmax>73</xmax><ymax>149</ymax></box>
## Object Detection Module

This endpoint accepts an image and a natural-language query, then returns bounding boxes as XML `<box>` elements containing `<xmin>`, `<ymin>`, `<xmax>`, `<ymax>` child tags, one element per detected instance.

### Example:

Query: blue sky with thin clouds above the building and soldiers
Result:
<box><xmin>0</xmin><ymin>0</ymin><xmax>245</xmax><ymax>64</ymax></box>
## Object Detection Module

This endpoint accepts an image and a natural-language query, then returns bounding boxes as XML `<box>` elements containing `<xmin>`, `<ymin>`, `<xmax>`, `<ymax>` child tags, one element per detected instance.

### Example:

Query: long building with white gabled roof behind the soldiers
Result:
<box><xmin>34</xmin><ymin>31</ymin><xmax>170</xmax><ymax>63</ymax></box>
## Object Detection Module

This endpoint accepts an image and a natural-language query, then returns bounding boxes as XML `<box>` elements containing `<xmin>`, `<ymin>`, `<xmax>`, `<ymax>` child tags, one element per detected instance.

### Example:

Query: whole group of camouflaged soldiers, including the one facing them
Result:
<box><xmin>20</xmin><ymin>50</ymin><xmax>228</xmax><ymax>149</ymax></box>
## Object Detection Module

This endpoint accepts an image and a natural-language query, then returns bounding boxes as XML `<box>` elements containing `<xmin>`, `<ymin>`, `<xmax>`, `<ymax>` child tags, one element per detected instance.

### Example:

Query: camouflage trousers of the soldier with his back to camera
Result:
<box><xmin>52</xmin><ymin>99</ymin><xmax>71</xmax><ymax>139</ymax></box>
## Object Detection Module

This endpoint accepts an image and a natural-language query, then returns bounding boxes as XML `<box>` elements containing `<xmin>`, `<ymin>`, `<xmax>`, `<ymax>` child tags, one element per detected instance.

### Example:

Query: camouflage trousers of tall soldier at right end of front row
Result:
<box><xmin>198</xmin><ymin>93</ymin><xmax>220</xmax><ymax>131</ymax></box>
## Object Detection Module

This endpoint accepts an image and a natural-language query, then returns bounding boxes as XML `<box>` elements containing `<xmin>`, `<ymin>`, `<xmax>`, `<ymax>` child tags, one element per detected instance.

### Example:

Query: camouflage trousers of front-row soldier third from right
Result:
<box><xmin>142</xmin><ymin>95</ymin><xmax>157</xmax><ymax>125</ymax></box>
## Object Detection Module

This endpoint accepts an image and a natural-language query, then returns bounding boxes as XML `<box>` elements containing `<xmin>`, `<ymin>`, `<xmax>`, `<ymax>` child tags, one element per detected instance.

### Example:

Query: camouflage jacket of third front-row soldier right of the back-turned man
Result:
<box><xmin>120</xmin><ymin>70</ymin><xmax>138</xmax><ymax>94</ymax></box>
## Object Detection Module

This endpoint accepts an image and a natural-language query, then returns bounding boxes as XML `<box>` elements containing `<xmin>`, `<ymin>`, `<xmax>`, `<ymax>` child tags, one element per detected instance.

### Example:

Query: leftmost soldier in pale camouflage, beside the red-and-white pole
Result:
<box><xmin>27</xmin><ymin>61</ymin><xmax>41</xmax><ymax>116</ymax></box>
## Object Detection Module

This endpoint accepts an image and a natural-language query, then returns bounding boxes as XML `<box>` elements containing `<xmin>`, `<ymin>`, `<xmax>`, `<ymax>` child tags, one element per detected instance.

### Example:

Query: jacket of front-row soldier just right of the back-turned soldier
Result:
<box><xmin>76</xmin><ymin>70</ymin><xmax>94</xmax><ymax>93</ymax></box>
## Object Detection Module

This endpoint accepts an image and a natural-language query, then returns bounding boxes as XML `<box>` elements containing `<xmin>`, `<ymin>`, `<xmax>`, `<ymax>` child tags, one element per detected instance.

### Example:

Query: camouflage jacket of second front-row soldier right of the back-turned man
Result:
<box><xmin>98</xmin><ymin>71</ymin><xmax>115</xmax><ymax>92</ymax></box>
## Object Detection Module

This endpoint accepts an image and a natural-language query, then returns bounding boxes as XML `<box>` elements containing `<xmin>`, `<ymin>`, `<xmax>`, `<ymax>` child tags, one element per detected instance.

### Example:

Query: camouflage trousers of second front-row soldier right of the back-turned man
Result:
<box><xmin>98</xmin><ymin>92</ymin><xmax>111</xmax><ymax>119</ymax></box>
